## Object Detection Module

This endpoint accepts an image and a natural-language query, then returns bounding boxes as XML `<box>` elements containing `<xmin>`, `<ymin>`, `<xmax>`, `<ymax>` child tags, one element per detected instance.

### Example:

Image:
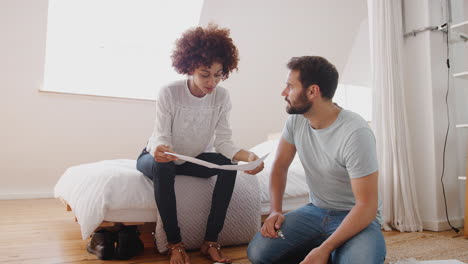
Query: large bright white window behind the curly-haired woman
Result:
<box><xmin>41</xmin><ymin>0</ymin><xmax>203</xmax><ymax>99</ymax></box>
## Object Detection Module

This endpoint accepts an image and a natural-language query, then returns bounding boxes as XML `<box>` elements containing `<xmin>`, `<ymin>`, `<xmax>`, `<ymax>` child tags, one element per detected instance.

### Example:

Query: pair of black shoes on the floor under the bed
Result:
<box><xmin>86</xmin><ymin>226</ymin><xmax>144</xmax><ymax>260</ymax></box>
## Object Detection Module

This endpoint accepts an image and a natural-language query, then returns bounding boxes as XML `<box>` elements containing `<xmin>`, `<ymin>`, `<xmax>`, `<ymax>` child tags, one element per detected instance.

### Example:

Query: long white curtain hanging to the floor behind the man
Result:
<box><xmin>367</xmin><ymin>0</ymin><xmax>422</xmax><ymax>232</ymax></box>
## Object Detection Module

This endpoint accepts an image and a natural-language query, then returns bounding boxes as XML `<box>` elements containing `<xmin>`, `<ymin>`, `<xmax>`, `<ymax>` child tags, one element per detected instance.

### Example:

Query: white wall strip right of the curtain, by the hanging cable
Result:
<box><xmin>404</xmin><ymin>0</ymin><xmax>463</xmax><ymax>230</ymax></box>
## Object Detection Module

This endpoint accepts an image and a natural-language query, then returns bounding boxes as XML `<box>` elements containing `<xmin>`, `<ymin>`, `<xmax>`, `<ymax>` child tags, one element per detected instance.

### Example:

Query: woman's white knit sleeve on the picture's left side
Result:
<box><xmin>146</xmin><ymin>88</ymin><xmax>173</xmax><ymax>156</ymax></box>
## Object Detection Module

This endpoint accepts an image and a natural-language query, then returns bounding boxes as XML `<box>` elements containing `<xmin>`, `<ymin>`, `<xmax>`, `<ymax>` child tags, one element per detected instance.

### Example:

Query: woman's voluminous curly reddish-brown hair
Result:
<box><xmin>171</xmin><ymin>24</ymin><xmax>239</xmax><ymax>80</ymax></box>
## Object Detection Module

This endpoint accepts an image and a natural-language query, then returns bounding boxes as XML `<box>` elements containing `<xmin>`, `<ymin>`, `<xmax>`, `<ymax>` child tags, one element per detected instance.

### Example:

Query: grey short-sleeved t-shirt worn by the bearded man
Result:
<box><xmin>282</xmin><ymin>109</ymin><xmax>380</xmax><ymax>218</ymax></box>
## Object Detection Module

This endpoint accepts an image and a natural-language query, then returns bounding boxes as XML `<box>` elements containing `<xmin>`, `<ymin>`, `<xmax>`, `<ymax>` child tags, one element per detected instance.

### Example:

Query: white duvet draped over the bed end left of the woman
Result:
<box><xmin>54</xmin><ymin>159</ymin><xmax>157</xmax><ymax>239</ymax></box>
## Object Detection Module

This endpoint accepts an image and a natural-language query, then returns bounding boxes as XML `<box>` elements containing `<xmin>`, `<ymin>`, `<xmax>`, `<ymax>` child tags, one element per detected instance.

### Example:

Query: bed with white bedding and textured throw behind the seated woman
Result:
<box><xmin>54</xmin><ymin>139</ymin><xmax>308</xmax><ymax>252</ymax></box>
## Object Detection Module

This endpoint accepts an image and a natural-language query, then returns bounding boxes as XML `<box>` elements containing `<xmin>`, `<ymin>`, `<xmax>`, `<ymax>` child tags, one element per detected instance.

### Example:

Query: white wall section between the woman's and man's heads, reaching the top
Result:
<box><xmin>200</xmin><ymin>0</ymin><xmax>370</xmax><ymax>147</ymax></box>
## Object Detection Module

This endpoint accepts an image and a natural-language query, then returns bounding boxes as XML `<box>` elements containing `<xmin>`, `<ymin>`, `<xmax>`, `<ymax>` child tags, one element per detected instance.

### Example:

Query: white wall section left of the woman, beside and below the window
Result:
<box><xmin>0</xmin><ymin>0</ymin><xmax>154</xmax><ymax>199</ymax></box>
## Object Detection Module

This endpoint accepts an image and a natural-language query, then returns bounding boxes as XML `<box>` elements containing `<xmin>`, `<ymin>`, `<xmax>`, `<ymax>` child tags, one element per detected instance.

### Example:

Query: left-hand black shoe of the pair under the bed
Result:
<box><xmin>86</xmin><ymin>229</ymin><xmax>115</xmax><ymax>260</ymax></box>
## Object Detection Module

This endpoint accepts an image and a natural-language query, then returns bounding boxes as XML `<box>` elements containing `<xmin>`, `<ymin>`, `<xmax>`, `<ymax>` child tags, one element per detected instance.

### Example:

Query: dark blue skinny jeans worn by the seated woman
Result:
<box><xmin>137</xmin><ymin>150</ymin><xmax>237</xmax><ymax>244</ymax></box>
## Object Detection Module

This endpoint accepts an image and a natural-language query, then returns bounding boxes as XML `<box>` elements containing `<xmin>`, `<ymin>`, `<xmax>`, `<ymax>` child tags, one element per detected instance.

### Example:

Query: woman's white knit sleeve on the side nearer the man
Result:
<box><xmin>214</xmin><ymin>94</ymin><xmax>241</xmax><ymax>160</ymax></box>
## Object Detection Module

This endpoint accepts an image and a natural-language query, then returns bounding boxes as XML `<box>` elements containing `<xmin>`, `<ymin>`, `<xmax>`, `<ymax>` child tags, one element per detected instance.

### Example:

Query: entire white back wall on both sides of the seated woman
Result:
<box><xmin>0</xmin><ymin>0</ymin><xmax>367</xmax><ymax>199</ymax></box>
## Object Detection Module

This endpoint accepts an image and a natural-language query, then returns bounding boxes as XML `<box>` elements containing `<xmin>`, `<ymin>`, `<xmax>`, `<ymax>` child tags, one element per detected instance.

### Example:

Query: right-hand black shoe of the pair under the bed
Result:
<box><xmin>115</xmin><ymin>226</ymin><xmax>144</xmax><ymax>260</ymax></box>
